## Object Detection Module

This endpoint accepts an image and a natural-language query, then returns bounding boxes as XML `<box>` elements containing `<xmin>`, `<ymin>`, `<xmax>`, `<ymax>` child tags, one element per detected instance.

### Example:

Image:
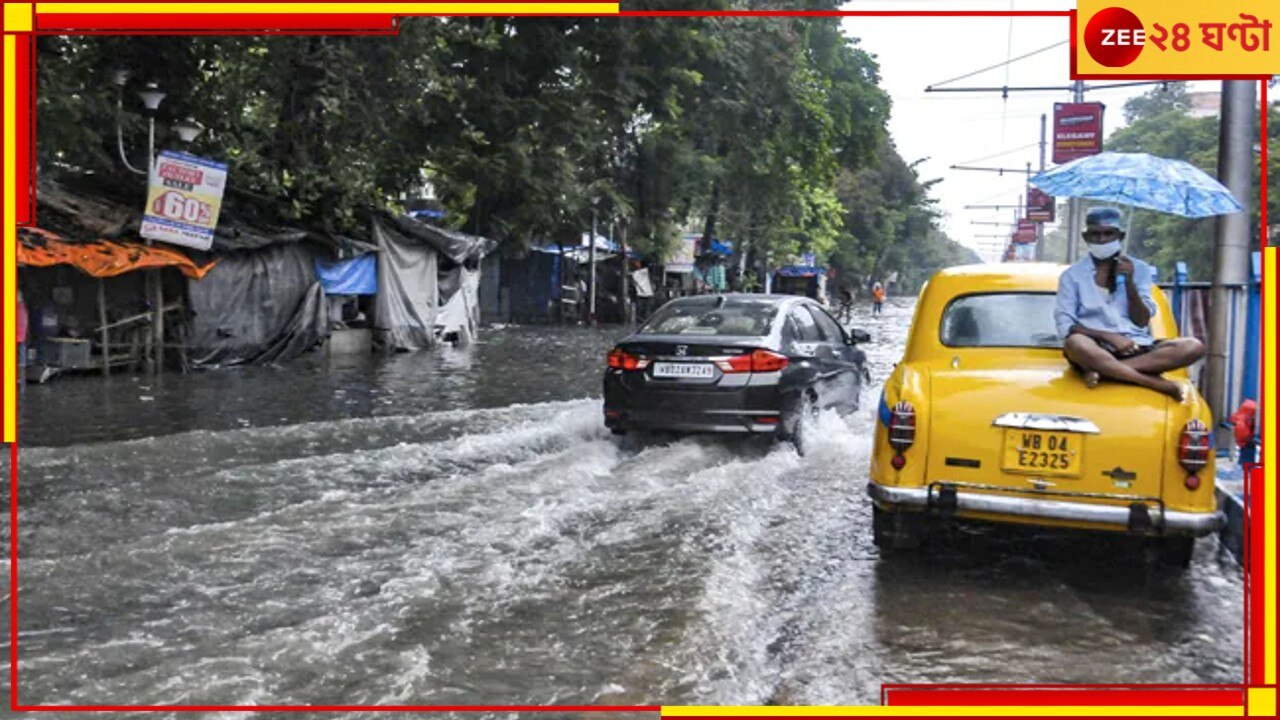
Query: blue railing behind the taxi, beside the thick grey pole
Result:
<box><xmin>1157</xmin><ymin>252</ymin><xmax>1262</xmax><ymax>445</ymax></box>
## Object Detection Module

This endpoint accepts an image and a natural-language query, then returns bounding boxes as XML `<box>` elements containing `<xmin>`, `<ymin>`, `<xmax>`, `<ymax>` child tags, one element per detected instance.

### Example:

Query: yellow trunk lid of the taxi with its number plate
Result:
<box><xmin>925</xmin><ymin>363</ymin><xmax>1170</xmax><ymax>502</ymax></box>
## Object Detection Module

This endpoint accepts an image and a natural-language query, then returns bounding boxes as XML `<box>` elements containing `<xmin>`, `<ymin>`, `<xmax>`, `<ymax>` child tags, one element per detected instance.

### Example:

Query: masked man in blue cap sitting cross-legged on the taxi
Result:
<box><xmin>1053</xmin><ymin>208</ymin><xmax>1204</xmax><ymax>401</ymax></box>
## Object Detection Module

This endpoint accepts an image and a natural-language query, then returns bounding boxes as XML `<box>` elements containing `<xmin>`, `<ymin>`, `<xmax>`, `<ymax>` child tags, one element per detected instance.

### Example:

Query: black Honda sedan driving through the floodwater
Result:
<box><xmin>604</xmin><ymin>295</ymin><xmax>869</xmax><ymax>451</ymax></box>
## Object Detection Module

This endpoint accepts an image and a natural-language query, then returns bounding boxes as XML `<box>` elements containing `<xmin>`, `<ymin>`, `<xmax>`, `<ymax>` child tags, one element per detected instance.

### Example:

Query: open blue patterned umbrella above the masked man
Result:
<box><xmin>1030</xmin><ymin>152</ymin><xmax>1244</xmax><ymax>218</ymax></box>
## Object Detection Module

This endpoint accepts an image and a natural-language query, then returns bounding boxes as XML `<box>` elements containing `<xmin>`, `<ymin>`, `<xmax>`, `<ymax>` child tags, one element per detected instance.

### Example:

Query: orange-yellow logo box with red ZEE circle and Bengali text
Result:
<box><xmin>1071</xmin><ymin>0</ymin><xmax>1280</xmax><ymax>79</ymax></box>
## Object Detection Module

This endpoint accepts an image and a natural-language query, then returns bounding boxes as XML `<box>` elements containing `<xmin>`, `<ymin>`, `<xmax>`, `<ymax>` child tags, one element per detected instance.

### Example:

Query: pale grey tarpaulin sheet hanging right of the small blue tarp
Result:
<box><xmin>374</xmin><ymin>218</ymin><xmax>438</xmax><ymax>350</ymax></box>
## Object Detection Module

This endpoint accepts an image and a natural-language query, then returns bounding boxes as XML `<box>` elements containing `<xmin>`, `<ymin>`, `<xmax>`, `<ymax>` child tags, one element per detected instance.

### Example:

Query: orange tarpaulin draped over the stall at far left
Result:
<box><xmin>18</xmin><ymin>228</ymin><xmax>216</xmax><ymax>281</ymax></box>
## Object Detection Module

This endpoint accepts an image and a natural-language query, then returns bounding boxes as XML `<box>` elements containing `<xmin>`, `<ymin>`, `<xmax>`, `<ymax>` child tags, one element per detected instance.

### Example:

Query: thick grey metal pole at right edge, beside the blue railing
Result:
<box><xmin>1204</xmin><ymin>81</ymin><xmax>1257</xmax><ymax>448</ymax></box>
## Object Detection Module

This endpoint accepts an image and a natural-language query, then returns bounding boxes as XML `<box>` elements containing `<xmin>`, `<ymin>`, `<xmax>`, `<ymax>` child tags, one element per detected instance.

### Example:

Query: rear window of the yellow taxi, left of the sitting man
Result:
<box><xmin>941</xmin><ymin>292</ymin><xmax>1062</xmax><ymax>347</ymax></box>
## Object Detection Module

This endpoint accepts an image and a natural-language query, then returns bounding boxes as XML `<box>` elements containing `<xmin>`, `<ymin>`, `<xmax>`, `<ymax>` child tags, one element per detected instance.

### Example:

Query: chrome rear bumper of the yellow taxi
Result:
<box><xmin>867</xmin><ymin>483</ymin><xmax>1225</xmax><ymax>537</ymax></box>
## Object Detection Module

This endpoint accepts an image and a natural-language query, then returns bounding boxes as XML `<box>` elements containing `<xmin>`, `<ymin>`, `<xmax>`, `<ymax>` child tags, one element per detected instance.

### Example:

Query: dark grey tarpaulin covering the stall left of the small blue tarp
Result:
<box><xmin>188</xmin><ymin>243</ymin><xmax>329</xmax><ymax>365</ymax></box>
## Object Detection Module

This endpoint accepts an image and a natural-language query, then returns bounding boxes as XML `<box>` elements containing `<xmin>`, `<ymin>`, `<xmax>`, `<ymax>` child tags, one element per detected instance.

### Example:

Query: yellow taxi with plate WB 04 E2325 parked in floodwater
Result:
<box><xmin>868</xmin><ymin>263</ymin><xmax>1221</xmax><ymax>568</ymax></box>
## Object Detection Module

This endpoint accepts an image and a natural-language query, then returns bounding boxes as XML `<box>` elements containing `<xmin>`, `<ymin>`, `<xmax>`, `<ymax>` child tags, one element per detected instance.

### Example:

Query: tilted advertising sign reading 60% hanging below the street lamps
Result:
<box><xmin>141</xmin><ymin>150</ymin><xmax>227</xmax><ymax>250</ymax></box>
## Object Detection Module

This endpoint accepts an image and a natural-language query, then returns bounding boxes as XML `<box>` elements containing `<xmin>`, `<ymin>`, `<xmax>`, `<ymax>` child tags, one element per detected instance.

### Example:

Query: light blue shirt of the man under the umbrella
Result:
<box><xmin>1053</xmin><ymin>255</ymin><xmax>1156</xmax><ymax>346</ymax></box>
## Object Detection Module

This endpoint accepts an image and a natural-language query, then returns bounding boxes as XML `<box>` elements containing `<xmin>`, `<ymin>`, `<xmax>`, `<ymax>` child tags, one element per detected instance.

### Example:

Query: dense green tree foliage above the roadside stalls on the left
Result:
<box><xmin>37</xmin><ymin>14</ymin><xmax>972</xmax><ymax>285</ymax></box>
